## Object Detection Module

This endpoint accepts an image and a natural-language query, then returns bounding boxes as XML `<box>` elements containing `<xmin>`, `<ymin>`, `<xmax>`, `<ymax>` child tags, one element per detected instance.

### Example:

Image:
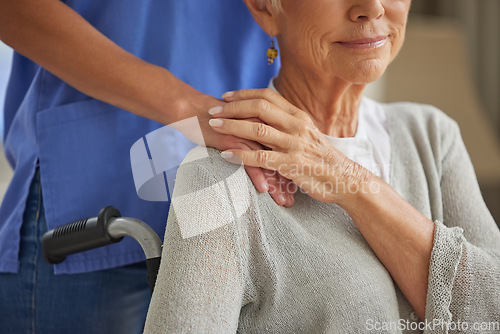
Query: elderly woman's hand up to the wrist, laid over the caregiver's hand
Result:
<box><xmin>210</xmin><ymin>89</ymin><xmax>376</xmax><ymax>204</ymax></box>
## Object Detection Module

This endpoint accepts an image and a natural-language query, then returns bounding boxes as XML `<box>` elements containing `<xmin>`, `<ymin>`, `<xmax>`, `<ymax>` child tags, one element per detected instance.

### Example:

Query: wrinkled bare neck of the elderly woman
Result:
<box><xmin>274</xmin><ymin>68</ymin><xmax>365</xmax><ymax>137</ymax></box>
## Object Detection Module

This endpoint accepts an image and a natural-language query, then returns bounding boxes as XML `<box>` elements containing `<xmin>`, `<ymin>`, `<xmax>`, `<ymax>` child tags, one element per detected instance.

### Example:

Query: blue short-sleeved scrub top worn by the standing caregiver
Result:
<box><xmin>0</xmin><ymin>0</ymin><xmax>278</xmax><ymax>273</ymax></box>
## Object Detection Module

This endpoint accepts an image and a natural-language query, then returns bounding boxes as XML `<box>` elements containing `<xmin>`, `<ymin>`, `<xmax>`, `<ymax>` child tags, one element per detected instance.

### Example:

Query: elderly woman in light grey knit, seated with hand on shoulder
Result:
<box><xmin>145</xmin><ymin>0</ymin><xmax>500</xmax><ymax>333</ymax></box>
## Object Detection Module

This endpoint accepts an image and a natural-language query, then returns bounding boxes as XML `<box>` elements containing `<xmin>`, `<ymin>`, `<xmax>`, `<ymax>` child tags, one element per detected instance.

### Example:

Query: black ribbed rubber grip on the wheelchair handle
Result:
<box><xmin>42</xmin><ymin>206</ymin><xmax>123</xmax><ymax>264</ymax></box>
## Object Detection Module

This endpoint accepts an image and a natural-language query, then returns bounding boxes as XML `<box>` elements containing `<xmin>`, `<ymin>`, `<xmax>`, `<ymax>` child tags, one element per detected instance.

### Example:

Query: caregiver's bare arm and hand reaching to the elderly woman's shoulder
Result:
<box><xmin>0</xmin><ymin>0</ymin><xmax>291</xmax><ymax>205</ymax></box>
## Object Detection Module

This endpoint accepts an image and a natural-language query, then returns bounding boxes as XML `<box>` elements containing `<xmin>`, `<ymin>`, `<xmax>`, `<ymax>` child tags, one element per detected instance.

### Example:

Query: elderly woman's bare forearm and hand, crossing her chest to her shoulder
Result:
<box><xmin>209</xmin><ymin>89</ymin><xmax>434</xmax><ymax>319</ymax></box>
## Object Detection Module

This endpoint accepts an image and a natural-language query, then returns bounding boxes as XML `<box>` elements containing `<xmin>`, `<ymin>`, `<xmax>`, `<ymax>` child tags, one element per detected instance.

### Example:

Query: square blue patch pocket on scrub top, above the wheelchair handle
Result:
<box><xmin>36</xmin><ymin>99</ymin><xmax>168</xmax><ymax>268</ymax></box>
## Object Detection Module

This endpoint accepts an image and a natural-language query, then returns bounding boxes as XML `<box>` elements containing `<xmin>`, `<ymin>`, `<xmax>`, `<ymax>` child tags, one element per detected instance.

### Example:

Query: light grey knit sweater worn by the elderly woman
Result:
<box><xmin>145</xmin><ymin>103</ymin><xmax>500</xmax><ymax>334</ymax></box>
